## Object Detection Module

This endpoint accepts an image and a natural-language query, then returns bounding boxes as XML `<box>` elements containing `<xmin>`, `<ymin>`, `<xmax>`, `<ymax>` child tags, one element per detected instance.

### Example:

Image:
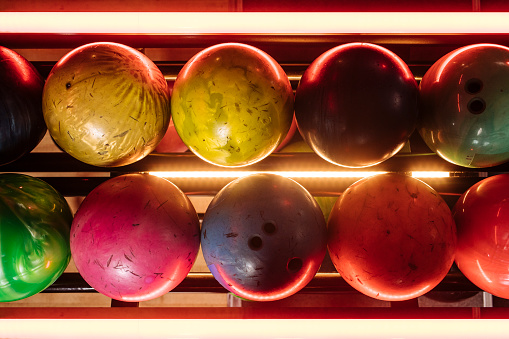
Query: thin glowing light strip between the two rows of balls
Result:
<box><xmin>149</xmin><ymin>171</ymin><xmax>449</xmax><ymax>179</ymax></box>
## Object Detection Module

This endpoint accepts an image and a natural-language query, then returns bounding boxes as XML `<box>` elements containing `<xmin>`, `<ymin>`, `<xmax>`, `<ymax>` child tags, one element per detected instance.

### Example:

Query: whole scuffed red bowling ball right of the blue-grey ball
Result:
<box><xmin>328</xmin><ymin>173</ymin><xmax>456</xmax><ymax>301</ymax></box>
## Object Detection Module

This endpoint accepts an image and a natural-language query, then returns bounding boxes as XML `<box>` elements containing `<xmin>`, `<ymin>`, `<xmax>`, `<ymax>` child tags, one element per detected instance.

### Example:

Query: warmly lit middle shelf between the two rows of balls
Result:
<box><xmin>0</xmin><ymin>152</ymin><xmax>500</xmax><ymax>197</ymax></box>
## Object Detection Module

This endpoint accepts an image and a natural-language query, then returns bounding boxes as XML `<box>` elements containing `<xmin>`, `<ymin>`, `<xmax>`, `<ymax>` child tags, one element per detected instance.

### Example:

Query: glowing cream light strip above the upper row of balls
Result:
<box><xmin>0</xmin><ymin>12</ymin><xmax>509</xmax><ymax>34</ymax></box>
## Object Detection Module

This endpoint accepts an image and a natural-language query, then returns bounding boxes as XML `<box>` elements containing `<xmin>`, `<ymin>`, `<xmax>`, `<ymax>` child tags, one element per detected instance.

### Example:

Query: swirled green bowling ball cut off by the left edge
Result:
<box><xmin>0</xmin><ymin>173</ymin><xmax>72</xmax><ymax>302</ymax></box>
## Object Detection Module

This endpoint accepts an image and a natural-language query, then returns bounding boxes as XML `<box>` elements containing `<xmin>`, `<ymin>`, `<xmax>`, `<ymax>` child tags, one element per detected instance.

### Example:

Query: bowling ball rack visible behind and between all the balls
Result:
<box><xmin>0</xmin><ymin>21</ymin><xmax>509</xmax><ymax>318</ymax></box>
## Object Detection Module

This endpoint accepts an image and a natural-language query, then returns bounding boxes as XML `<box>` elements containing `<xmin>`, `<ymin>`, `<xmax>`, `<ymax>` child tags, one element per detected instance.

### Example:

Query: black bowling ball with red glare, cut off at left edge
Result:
<box><xmin>0</xmin><ymin>46</ymin><xmax>46</xmax><ymax>165</ymax></box>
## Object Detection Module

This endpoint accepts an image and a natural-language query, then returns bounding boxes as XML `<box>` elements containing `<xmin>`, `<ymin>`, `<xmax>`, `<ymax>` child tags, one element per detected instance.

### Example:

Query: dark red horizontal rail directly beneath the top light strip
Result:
<box><xmin>4</xmin><ymin>32</ymin><xmax>509</xmax><ymax>51</ymax></box>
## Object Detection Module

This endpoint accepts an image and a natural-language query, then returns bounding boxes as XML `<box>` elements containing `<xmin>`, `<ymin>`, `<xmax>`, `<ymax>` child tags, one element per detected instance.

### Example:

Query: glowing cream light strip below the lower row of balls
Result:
<box><xmin>0</xmin><ymin>320</ymin><xmax>507</xmax><ymax>339</ymax></box>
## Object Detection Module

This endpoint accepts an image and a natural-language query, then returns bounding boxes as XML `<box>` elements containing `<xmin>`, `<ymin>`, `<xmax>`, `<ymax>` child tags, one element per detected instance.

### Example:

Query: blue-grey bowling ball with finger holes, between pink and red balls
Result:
<box><xmin>201</xmin><ymin>173</ymin><xmax>327</xmax><ymax>301</ymax></box>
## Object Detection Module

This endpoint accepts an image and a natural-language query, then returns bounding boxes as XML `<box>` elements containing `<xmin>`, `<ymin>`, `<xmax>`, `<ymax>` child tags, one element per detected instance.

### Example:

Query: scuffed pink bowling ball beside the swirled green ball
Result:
<box><xmin>71</xmin><ymin>174</ymin><xmax>200</xmax><ymax>302</ymax></box>
